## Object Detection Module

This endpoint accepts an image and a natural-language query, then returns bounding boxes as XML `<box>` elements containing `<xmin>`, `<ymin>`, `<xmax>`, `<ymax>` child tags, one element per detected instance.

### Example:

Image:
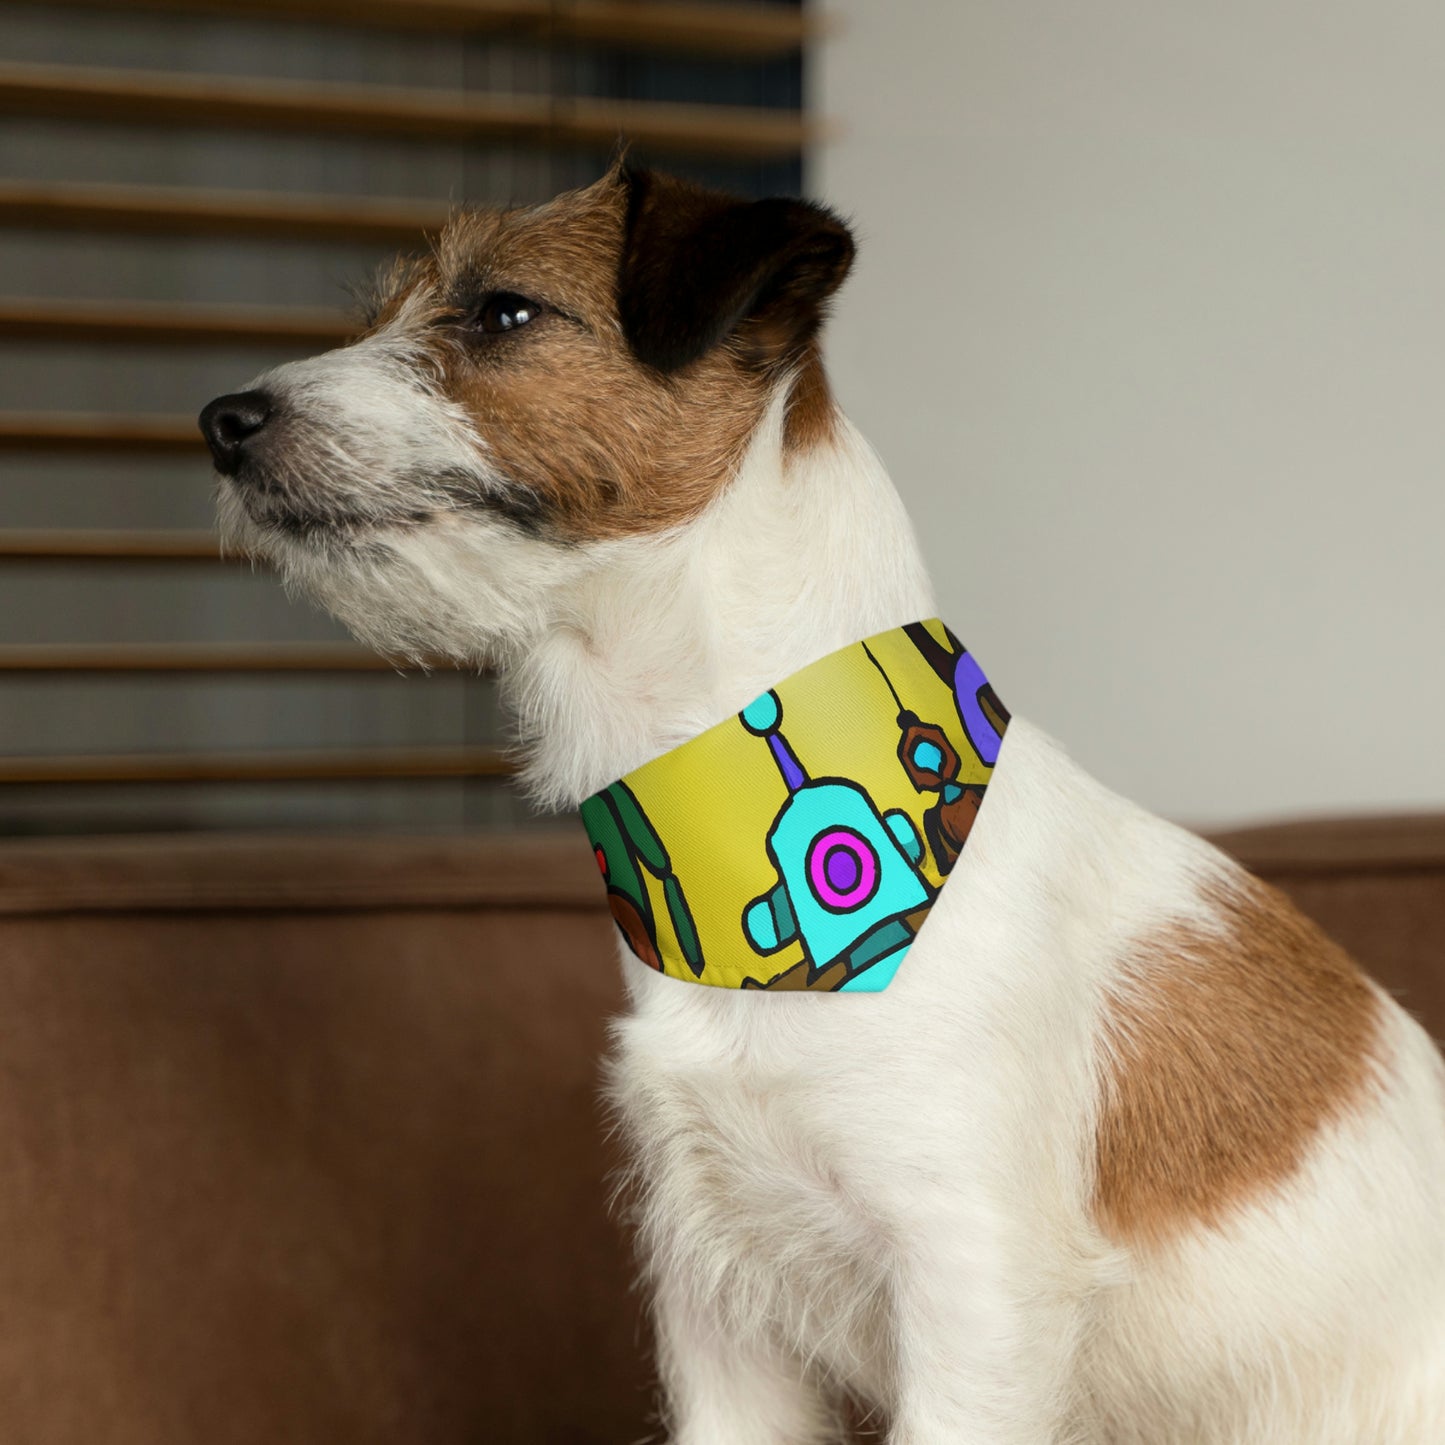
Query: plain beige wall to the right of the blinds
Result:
<box><xmin>809</xmin><ymin>0</ymin><xmax>1445</xmax><ymax>822</ymax></box>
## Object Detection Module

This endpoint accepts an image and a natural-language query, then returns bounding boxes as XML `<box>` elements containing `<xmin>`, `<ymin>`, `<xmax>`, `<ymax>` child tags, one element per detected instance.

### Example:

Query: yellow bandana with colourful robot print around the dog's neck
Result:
<box><xmin>582</xmin><ymin>618</ymin><xmax>1009</xmax><ymax>993</ymax></box>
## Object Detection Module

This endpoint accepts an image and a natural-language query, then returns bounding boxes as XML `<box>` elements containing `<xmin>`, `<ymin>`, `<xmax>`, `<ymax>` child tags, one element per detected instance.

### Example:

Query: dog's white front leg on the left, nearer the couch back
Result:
<box><xmin>653</xmin><ymin>1280</ymin><xmax>841</xmax><ymax>1445</ymax></box>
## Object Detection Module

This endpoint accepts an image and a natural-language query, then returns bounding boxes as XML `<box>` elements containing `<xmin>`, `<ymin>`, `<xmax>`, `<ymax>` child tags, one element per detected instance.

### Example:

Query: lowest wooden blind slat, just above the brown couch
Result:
<box><xmin>0</xmin><ymin>747</ymin><xmax>514</xmax><ymax>783</ymax></box>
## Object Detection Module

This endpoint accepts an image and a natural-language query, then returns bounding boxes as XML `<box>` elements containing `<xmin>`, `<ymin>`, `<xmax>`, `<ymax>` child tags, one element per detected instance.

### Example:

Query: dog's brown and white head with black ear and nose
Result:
<box><xmin>201</xmin><ymin>166</ymin><xmax>853</xmax><ymax>659</ymax></box>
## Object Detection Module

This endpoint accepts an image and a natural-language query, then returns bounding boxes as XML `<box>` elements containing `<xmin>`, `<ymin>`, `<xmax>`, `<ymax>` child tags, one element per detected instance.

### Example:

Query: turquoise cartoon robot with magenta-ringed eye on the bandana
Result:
<box><xmin>740</xmin><ymin>692</ymin><xmax>933</xmax><ymax>991</ymax></box>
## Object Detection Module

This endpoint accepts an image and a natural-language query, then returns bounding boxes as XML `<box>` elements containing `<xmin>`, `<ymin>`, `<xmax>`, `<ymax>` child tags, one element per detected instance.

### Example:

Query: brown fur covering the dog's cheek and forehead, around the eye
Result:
<box><xmin>361</xmin><ymin>171</ymin><xmax>849</xmax><ymax>540</ymax></box>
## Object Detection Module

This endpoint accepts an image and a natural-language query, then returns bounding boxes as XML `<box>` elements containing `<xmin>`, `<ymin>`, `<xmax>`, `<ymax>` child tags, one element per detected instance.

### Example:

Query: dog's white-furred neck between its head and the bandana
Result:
<box><xmin>504</xmin><ymin>397</ymin><xmax>933</xmax><ymax>808</ymax></box>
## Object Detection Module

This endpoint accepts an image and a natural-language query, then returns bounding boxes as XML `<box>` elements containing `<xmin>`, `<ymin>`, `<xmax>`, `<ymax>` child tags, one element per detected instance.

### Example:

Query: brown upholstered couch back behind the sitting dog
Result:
<box><xmin>0</xmin><ymin>818</ymin><xmax>1445</xmax><ymax>1445</ymax></box>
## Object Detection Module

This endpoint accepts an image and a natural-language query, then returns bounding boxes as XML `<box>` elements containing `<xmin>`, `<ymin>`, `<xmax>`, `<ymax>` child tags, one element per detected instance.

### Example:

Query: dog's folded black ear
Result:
<box><xmin>617</xmin><ymin>166</ymin><xmax>853</xmax><ymax>373</ymax></box>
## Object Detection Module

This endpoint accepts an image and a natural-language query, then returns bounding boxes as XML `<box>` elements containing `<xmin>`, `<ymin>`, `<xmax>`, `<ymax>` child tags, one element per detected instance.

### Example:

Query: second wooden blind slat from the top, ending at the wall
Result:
<box><xmin>0</xmin><ymin>64</ymin><xmax>818</xmax><ymax>160</ymax></box>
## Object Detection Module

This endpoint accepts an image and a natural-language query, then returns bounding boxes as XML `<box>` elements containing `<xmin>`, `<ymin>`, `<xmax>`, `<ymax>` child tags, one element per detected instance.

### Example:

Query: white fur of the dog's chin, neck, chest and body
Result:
<box><xmin>216</xmin><ymin>349</ymin><xmax>1445</xmax><ymax>1445</ymax></box>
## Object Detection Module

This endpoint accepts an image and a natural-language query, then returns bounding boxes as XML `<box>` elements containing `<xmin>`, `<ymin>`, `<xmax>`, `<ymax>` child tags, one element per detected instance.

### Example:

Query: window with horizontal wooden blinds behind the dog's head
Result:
<box><xmin>0</xmin><ymin>0</ymin><xmax>805</xmax><ymax>834</ymax></box>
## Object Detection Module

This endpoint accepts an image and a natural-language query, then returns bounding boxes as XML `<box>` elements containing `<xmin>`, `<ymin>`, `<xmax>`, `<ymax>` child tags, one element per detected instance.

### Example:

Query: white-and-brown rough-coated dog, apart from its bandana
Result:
<box><xmin>201</xmin><ymin>163</ymin><xmax>1445</xmax><ymax>1445</ymax></box>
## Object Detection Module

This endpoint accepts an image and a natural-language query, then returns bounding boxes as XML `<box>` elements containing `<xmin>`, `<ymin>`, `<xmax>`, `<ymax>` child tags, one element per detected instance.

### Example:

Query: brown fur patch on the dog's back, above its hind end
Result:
<box><xmin>1094</xmin><ymin>874</ymin><xmax>1380</xmax><ymax>1244</ymax></box>
